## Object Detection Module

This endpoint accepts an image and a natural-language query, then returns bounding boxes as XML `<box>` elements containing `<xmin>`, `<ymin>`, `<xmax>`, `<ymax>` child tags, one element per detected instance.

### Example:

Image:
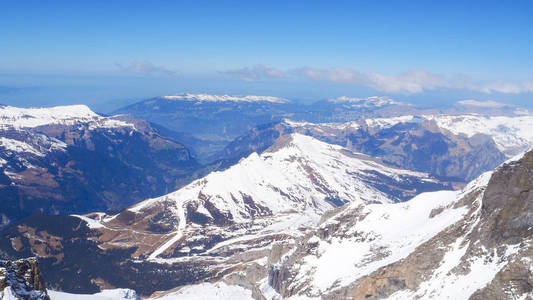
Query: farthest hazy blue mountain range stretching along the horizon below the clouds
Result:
<box><xmin>114</xmin><ymin>94</ymin><xmax>528</xmax><ymax>163</ymax></box>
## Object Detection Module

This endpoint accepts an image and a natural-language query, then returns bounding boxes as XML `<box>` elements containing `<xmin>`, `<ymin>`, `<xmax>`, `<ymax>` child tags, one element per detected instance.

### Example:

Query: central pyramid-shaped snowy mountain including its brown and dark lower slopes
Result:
<box><xmin>0</xmin><ymin>134</ymin><xmax>446</xmax><ymax>295</ymax></box>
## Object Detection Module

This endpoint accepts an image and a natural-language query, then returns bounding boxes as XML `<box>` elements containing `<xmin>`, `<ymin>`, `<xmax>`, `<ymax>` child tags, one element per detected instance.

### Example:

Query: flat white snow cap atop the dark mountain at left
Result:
<box><xmin>0</xmin><ymin>105</ymin><xmax>133</xmax><ymax>129</ymax></box>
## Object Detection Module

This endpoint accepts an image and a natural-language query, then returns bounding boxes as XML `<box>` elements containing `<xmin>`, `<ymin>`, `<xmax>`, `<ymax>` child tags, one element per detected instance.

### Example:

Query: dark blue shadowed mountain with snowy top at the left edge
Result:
<box><xmin>0</xmin><ymin>106</ymin><xmax>198</xmax><ymax>226</ymax></box>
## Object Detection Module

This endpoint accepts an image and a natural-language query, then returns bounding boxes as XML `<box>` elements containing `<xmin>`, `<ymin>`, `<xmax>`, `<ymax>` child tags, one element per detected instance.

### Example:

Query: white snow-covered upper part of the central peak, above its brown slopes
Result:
<box><xmin>128</xmin><ymin>134</ymin><xmax>437</xmax><ymax>229</ymax></box>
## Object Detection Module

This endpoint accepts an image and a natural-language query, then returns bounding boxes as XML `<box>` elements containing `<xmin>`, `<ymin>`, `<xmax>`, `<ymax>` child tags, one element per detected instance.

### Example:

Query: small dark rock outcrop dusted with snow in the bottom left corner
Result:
<box><xmin>0</xmin><ymin>258</ymin><xmax>50</xmax><ymax>300</ymax></box>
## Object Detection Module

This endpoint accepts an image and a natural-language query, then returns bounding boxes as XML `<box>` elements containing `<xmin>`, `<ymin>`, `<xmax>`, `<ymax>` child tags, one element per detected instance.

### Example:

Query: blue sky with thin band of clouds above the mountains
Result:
<box><xmin>0</xmin><ymin>1</ymin><xmax>533</xmax><ymax>110</ymax></box>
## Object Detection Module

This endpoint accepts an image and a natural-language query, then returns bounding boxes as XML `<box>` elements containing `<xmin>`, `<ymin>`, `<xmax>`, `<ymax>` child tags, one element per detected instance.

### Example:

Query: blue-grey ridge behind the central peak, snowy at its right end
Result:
<box><xmin>211</xmin><ymin>115</ymin><xmax>533</xmax><ymax>184</ymax></box>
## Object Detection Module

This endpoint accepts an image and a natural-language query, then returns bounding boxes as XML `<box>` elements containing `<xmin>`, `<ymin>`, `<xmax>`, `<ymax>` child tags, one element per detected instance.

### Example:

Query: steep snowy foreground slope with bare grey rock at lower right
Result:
<box><xmin>145</xmin><ymin>151</ymin><xmax>533</xmax><ymax>300</ymax></box>
